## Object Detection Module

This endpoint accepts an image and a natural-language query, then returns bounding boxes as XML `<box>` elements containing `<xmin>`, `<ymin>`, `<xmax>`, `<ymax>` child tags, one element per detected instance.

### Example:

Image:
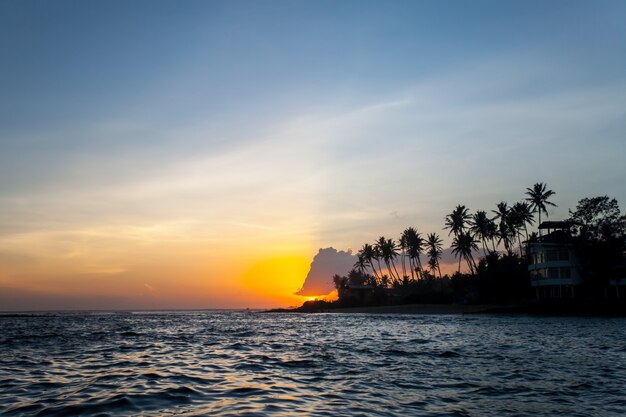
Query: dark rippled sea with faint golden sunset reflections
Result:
<box><xmin>0</xmin><ymin>312</ymin><xmax>626</xmax><ymax>417</ymax></box>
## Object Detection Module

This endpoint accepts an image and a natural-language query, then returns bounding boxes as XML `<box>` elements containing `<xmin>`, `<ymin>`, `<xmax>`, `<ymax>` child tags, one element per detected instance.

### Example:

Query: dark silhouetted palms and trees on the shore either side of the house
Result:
<box><xmin>312</xmin><ymin>183</ymin><xmax>626</xmax><ymax>307</ymax></box>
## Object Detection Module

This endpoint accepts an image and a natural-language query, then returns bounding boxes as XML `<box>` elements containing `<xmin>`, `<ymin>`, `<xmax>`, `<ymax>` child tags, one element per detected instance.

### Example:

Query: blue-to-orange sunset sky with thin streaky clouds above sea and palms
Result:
<box><xmin>0</xmin><ymin>0</ymin><xmax>626</xmax><ymax>310</ymax></box>
